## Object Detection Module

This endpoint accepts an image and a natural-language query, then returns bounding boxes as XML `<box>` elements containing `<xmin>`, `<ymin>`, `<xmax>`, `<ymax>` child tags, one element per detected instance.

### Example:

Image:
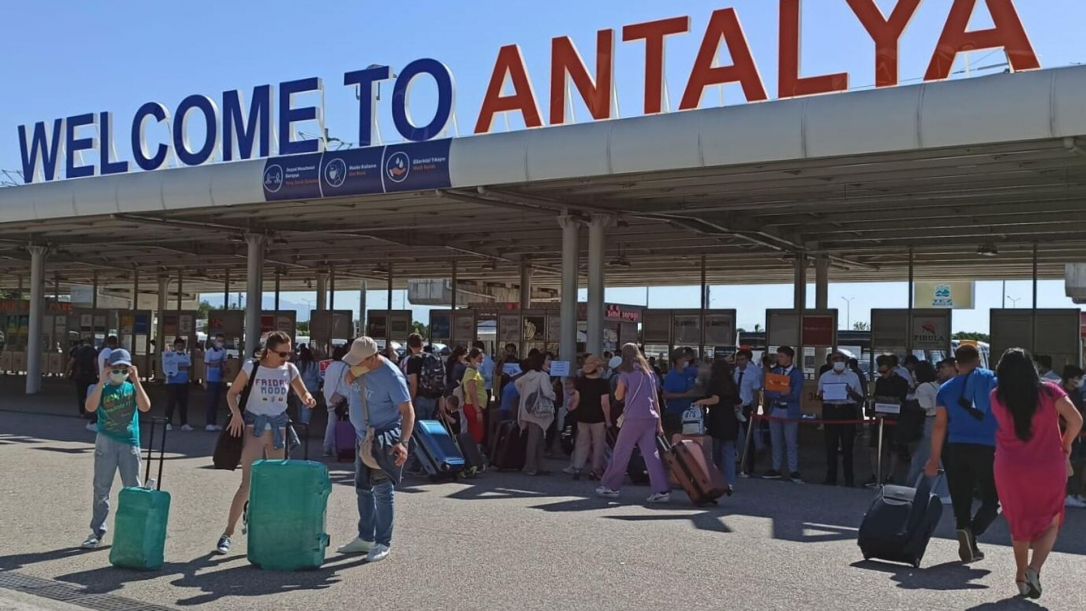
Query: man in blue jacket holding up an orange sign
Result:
<box><xmin>765</xmin><ymin>346</ymin><xmax>804</xmax><ymax>484</ymax></box>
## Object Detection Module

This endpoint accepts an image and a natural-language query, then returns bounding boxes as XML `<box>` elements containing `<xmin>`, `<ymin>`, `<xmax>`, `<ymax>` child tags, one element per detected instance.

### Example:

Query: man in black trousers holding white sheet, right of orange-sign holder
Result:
<box><xmin>818</xmin><ymin>352</ymin><xmax>863</xmax><ymax>488</ymax></box>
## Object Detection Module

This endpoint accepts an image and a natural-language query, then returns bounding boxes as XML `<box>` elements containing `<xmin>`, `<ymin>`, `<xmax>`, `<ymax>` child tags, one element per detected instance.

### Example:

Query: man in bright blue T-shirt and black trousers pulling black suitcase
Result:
<box><xmin>924</xmin><ymin>345</ymin><xmax>999</xmax><ymax>562</ymax></box>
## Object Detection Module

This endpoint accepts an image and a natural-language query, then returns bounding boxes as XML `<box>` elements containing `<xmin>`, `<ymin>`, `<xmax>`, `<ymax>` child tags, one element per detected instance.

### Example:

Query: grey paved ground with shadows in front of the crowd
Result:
<box><xmin>0</xmin><ymin>384</ymin><xmax>1086</xmax><ymax>611</ymax></box>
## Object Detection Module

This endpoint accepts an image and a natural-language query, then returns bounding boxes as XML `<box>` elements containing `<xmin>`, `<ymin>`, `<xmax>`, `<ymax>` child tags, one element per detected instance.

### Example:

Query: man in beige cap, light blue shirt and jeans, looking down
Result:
<box><xmin>338</xmin><ymin>336</ymin><xmax>415</xmax><ymax>562</ymax></box>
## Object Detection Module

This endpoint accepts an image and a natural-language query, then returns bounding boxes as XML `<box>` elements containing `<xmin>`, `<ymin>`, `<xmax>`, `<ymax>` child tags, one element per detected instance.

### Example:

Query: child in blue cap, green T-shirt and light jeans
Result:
<box><xmin>83</xmin><ymin>348</ymin><xmax>151</xmax><ymax>549</ymax></box>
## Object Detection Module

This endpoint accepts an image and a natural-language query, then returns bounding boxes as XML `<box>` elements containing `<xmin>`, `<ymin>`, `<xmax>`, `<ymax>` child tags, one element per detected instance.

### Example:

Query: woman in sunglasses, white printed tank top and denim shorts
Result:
<box><xmin>215</xmin><ymin>331</ymin><xmax>317</xmax><ymax>555</ymax></box>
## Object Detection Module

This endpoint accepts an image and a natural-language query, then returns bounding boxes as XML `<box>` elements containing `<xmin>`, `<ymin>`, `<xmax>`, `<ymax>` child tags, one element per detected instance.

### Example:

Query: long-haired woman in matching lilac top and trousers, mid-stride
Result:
<box><xmin>596</xmin><ymin>344</ymin><xmax>671</xmax><ymax>502</ymax></box>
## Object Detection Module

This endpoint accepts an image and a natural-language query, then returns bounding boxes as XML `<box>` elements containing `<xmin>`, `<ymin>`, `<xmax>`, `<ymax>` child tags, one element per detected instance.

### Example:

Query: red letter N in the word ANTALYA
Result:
<box><xmin>551</xmin><ymin>29</ymin><xmax>615</xmax><ymax>125</ymax></box>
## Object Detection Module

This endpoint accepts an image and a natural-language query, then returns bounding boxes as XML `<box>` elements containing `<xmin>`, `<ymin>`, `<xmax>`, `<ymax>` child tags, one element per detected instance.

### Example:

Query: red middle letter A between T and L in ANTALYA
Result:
<box><xmin>679</xmin><ymin>9</ymin><xmax>769</xmax><ymax>111</ymax></box>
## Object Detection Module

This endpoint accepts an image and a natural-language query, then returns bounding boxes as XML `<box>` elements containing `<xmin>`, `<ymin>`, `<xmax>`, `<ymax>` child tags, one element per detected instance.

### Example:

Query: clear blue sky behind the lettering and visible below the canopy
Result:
<box><xmin>0</xmin><ymin>0</ymin><xmax>1086</xmax><ymax>331</ymax></box>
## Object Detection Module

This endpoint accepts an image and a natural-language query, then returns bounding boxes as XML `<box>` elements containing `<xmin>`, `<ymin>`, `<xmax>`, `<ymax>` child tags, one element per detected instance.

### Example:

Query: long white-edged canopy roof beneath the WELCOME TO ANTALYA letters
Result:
<box><xmin>0</xmin><ymin>67</ymin><xmax>1086</xmax><ymax>292</ymax></box>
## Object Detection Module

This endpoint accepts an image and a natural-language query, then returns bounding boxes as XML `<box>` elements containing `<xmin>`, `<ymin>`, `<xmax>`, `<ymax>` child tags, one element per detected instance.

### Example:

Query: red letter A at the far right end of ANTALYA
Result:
<box><xmin>924</xmin><ymin>0</ymin><xmax>1040</xmax><ymax>80</ymax></box>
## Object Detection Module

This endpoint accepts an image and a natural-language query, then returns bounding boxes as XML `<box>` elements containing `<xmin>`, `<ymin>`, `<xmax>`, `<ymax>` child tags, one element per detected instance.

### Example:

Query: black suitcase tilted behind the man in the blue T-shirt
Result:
<box><xmin>857</xmin><ymin>478</ymin><xmax>943</xmax><ymax>569</ymax></box>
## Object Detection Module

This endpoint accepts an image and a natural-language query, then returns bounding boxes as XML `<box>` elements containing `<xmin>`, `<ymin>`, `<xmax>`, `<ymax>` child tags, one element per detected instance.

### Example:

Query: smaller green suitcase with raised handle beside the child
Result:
<box><xmin>110</xmin><ymin>419</ymin><xmax>169</xmax><ymax>571</ymax></box>
